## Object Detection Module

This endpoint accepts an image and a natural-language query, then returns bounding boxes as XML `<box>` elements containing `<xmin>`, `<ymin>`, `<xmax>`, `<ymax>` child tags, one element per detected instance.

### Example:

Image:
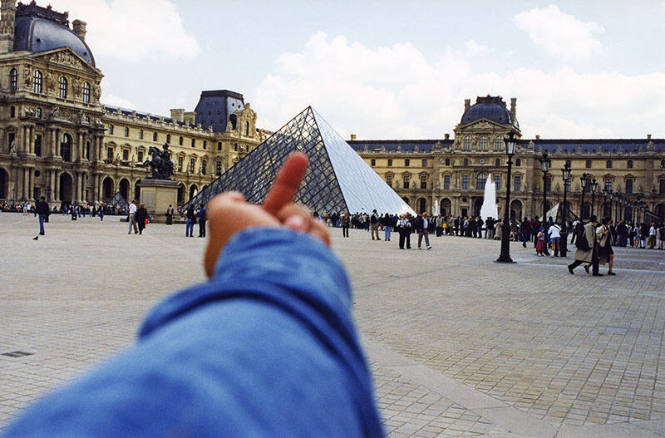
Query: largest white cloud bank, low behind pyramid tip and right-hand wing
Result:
<box><xmin>251</xmin><ymin>33</ymin><xmax>665</xmax><ymax>139</ymax></box>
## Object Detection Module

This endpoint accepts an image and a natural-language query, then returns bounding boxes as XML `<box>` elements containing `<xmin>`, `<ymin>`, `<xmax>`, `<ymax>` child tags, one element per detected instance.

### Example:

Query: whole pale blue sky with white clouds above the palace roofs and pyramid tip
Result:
<box><xmin>45</xmin><ymin>0</ymin><xmax>665</xmax><ymax>138</ymax></box>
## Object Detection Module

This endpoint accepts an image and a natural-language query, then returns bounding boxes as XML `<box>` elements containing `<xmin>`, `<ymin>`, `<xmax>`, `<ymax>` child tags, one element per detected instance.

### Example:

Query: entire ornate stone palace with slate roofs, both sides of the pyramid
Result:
<box><xmin>0</xmin><ymin>0</ymin><xmax>665</xmax><ymax>224</ymax></box>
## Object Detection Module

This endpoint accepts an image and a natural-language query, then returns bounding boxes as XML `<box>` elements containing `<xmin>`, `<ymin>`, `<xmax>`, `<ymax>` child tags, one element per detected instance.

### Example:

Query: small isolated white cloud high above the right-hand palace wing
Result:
<box><xmin>513</xmin><ymin>5</ymin><xmax>605</xmax><ymax>61</ymax></box>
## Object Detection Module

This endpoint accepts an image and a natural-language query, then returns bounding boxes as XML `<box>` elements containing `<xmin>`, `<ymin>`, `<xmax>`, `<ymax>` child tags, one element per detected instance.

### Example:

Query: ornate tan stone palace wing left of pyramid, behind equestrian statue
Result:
<box><xmin>0</xmin><ymin>0</ymin><xmax>266</xmax><ymax>206</ymax></box>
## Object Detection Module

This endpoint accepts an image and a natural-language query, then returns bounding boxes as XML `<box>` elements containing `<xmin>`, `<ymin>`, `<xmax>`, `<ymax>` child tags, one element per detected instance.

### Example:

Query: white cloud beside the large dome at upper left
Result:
<box><xmin>39</xmin><ymin>0</ymin><xmax>200</xmax><ymax>62</ymax></box>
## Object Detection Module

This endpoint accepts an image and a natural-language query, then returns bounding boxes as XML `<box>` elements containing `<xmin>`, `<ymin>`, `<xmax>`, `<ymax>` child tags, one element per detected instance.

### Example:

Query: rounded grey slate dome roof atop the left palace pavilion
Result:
<box><xmin>14</xmin><ymin>16</ymin><xmax>95</xmax><ymax>67</ymax></box>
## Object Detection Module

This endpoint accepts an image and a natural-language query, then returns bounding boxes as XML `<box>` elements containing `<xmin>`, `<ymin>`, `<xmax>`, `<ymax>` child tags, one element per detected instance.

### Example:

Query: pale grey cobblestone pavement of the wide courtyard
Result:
<box><xmin>0</xmin><ymin>213</ymin><xmax>665</xmax><ymax>437</ymax></box>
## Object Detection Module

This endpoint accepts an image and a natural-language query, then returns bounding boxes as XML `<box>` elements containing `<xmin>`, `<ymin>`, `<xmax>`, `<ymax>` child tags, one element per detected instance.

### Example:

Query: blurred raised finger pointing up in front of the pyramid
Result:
<box><xmin>263</xmin><ymin>152</ymin><xmax>309</xmax><ymax>216</ymax></box>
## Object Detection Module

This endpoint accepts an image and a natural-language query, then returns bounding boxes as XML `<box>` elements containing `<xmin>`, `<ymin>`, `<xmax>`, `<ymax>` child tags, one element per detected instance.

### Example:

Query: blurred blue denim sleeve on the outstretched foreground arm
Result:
<box><xmin>5</xmin><ymin>228</ymin><xmax>384</xmax><ymax>438</ymax></box>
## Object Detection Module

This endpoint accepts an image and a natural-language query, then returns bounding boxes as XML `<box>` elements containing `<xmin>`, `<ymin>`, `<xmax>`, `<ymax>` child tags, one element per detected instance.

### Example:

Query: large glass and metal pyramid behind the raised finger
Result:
<box><xmin>183</xmin><ymin>107</ymin><xmax>413</xmax><ymax>214</ymax></box>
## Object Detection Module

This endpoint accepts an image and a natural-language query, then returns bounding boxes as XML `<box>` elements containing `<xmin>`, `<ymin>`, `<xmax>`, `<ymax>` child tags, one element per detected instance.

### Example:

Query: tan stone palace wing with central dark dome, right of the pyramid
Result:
<box><xmin>349</xmin><ymin>96</ymin><xmax>665</xmax><ymax>219</ymax></box>
